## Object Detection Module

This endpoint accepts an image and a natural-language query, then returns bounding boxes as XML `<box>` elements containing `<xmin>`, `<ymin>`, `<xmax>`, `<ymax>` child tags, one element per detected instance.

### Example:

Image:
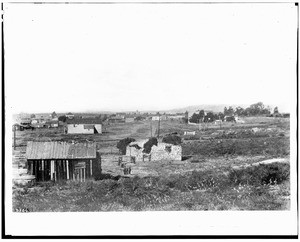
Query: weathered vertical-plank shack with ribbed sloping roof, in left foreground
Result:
<box><xmin>26</xmin><ymin>141</ymin><xmax>101</xmax><ymax>181</ymax></box>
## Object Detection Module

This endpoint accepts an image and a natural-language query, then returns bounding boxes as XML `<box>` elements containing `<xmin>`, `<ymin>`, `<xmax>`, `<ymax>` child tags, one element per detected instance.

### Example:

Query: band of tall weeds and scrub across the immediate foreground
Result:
<box><xmin>13</xmin><ymin>163</ymin><xmax>289</xmax><ymax>212</ymax></box>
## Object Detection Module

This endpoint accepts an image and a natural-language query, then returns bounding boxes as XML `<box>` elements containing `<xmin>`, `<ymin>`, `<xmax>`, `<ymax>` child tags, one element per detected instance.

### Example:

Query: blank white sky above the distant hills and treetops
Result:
<box><xmin>4</xmin><ymin>3</ymin><xmax>297</xmax><ymax>112</ymax></box>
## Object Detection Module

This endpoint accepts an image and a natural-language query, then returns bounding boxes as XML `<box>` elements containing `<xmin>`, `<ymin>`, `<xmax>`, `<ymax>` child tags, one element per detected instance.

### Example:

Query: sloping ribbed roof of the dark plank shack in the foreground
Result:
<box><xmin>26</xmin><ymin>141</ymin><xmax>96</xmax><ymax>160</ymax></box>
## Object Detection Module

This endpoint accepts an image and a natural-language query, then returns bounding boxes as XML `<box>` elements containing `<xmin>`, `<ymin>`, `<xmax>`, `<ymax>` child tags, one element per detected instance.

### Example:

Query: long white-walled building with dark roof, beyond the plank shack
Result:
<box><xmin>66</xmin><ymin>118</ymin><xmax>102</xmax><ymax>134</ymax></box>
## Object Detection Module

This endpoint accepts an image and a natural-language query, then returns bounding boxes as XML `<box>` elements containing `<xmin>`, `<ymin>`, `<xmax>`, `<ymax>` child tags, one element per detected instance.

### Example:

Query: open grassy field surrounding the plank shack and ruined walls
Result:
<box><xmin>13</xmin><ymin>117</ymin><xmax>290</xmax><ymax>211</ymax></box>
